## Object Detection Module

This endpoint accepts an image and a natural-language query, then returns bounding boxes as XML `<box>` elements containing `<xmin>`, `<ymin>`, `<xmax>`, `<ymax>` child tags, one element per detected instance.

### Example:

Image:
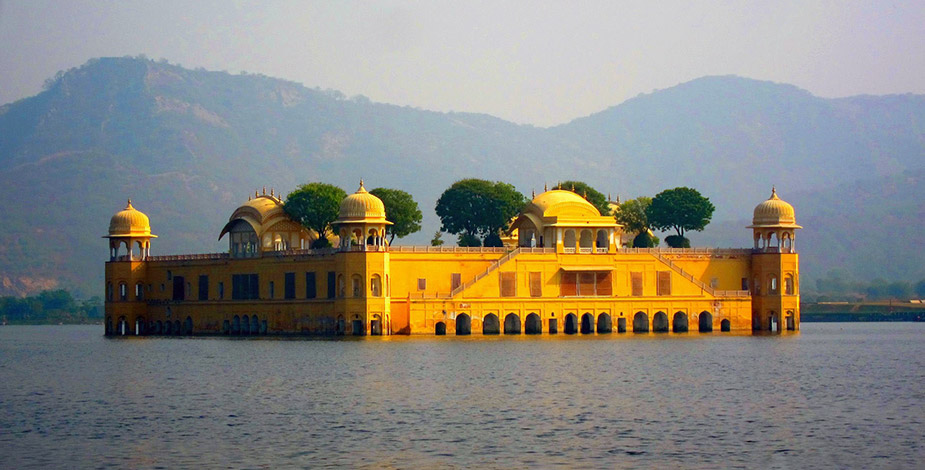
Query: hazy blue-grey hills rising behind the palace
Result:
<box><xmin>0</xmin><ymin>58</ymin><xmax>925</xmax><ymax>295</ymax></box>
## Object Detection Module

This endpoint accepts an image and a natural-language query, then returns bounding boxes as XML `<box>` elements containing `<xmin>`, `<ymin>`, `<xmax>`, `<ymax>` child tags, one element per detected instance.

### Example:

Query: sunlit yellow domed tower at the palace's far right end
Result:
<box><xmin>748</xmin><ymin>188</ymin><xmax>803</xmax><ymax>332</ymax></box>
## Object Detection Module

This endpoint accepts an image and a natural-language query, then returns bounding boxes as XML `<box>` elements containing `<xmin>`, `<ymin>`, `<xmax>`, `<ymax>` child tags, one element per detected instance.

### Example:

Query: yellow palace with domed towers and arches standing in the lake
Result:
<box><xmin>104</xmin><ymin>182</ymin><xmax>801</xmax><ymax>335</ymax></box>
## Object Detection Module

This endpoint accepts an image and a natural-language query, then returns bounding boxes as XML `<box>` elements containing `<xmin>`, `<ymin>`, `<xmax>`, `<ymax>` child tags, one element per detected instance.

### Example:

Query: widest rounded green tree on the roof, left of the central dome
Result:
<box><xmin>436</xmin><ymin>178</ymin><xmax>527</xmax><ymax>246</ymax></box>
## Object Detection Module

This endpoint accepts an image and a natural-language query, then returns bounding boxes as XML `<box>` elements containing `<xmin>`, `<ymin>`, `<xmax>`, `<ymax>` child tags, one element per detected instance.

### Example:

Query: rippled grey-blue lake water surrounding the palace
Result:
<box><xmin>0</xmin><ymin>323</ymin><xmax>925</xmax><ymax>468</ymax></box>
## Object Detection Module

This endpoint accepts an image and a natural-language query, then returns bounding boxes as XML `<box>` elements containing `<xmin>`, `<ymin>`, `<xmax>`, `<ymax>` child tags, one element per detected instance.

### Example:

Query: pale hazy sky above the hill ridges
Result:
<box><xmin>0</xmin><ymin>0</ymin><xmax>925</xmax><ymax>126</ymax></box>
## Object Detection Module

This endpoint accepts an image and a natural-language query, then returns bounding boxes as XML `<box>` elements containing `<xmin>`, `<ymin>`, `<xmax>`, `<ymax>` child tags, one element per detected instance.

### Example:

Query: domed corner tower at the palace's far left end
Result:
<box><xmin>103</xmin><ymin>199</ymin><xmax>157</xmax><ymax>335</ymax></box>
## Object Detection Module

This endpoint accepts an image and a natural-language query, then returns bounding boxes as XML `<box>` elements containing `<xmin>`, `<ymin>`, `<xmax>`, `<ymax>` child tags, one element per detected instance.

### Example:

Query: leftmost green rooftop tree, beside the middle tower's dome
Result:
<box><xmin>283</xmin><ymin>183</ymin><xmax>347</xmax><ymax>248</ymax></box>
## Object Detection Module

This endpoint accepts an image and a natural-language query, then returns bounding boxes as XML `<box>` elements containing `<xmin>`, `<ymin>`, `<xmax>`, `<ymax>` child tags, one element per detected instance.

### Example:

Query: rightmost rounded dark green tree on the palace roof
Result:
<box><xmin>646</xmin><ymin>187</ymin><xmax>715</xmax><ymax>241</ymax></box>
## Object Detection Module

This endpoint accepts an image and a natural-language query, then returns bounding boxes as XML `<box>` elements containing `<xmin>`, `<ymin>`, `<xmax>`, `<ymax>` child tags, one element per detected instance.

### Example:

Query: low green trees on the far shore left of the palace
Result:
<box><xmin>0</xmin><ymin>289</ymin><xmax>103</xmax><ymax>324</ymax></box>
